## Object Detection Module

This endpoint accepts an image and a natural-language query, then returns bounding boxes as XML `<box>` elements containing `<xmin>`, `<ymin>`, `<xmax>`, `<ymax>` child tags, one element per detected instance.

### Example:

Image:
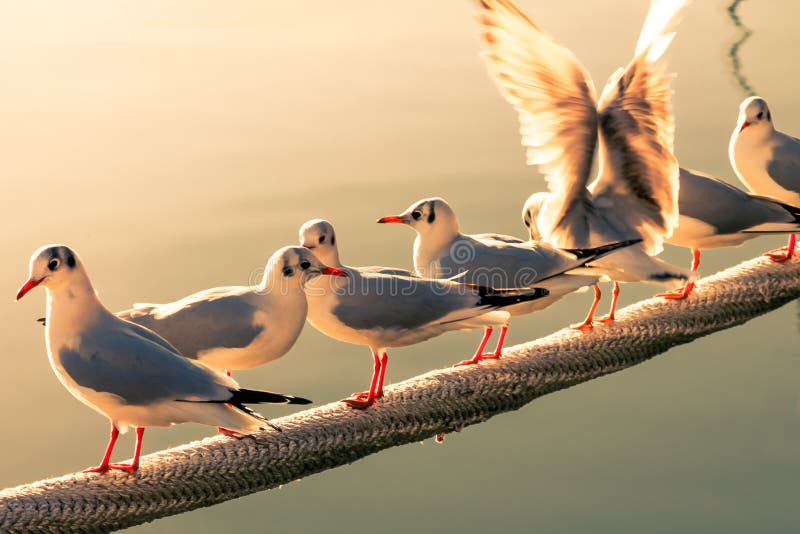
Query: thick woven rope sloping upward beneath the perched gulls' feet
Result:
<box><xmin>0</xmin><ymin>254</ymin><xmax>800</xmax><ymax>532</ymax></box>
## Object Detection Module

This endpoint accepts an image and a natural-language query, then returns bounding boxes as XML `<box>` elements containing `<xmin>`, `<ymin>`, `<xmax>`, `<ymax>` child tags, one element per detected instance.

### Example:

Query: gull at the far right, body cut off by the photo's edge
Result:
<box><xmin>728</xmin><ymin>96</ymin><xmax>800</xmax><ymax>262</ymax></box>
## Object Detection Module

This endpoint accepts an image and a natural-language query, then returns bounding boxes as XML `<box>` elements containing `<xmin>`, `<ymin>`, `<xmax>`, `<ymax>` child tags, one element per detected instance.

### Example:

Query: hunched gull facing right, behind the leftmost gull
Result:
<box><xmin>117</xmin><ymin>247</ymin><xmax>344</xmax><ymax>373</ymax></box>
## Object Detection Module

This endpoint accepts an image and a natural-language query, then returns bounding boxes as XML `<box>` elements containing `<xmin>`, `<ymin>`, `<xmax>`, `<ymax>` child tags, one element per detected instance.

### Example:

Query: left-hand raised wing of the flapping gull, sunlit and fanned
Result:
<box><xmin>479</xmin><ymin>0</ymin><xmax>597</xmax><ymax>243</ymax></box>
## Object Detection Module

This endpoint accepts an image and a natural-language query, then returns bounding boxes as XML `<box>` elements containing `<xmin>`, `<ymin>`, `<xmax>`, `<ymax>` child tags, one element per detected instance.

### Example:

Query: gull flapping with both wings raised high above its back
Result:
<box><xmin>479</xmin><ymin>0</ymin><xmax>689</xmax><ymax>329</ymax></box>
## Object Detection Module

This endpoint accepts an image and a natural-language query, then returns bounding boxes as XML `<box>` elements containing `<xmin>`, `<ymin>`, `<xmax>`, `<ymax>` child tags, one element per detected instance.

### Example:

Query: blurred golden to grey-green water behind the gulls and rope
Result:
<box><xmin>0</xmin><ymin>0</ymin><xmax>800</xmax><ymax>533</ymax></box>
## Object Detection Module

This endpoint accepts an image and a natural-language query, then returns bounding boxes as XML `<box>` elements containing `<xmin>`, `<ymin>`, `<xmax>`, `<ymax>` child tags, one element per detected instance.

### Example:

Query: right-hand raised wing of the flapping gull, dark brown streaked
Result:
<box><xmin>589</xmin><ymin>0</ymin><xmax>688</xmax><ymax>254</ymax></box>
